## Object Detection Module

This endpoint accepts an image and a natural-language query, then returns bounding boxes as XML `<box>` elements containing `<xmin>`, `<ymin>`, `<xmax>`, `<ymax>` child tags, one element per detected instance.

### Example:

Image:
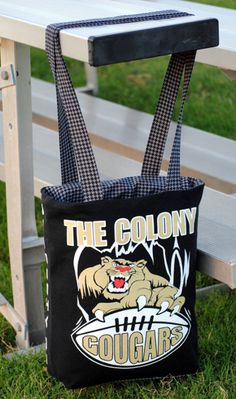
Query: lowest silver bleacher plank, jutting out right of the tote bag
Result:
<box><xmin>198</xmin><ymin>187</ymin><xmax>236</xmax><ymax>288</ymax></box>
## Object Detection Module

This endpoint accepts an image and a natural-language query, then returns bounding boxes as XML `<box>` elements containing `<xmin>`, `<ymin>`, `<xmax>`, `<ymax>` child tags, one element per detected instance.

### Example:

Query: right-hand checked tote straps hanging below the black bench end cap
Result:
<box><xmin>142</xmin><ymin>51</ymin><xmax>196</xmax><ymax>187</ymax></box>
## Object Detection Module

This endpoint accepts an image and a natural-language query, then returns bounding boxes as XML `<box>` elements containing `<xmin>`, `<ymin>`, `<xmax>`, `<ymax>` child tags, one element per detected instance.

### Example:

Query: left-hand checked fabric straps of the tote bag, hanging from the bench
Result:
<box><xmin>46</xmin><ymin>24</ymin><xmax>103</xmax><ymax>201</ymax></box>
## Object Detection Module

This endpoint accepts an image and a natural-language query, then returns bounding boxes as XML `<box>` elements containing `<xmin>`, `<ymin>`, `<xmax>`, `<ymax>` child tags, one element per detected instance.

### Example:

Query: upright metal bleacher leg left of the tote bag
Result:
<box><xmin>1</xmin><ymin>39</ymin><xmax>44</xmax><ymax>348</ymax></box>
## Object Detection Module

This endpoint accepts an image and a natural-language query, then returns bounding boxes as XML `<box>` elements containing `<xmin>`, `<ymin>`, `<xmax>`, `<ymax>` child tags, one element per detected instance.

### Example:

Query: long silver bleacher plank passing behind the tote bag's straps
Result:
<box><xmin>29</xmin><ymin>79</ymin><xmax>236</xmax><ymax>193</ymax></box>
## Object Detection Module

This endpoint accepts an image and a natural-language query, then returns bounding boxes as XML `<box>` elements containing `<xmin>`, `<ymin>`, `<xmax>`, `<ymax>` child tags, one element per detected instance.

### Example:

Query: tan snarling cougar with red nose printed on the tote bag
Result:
<box><xmin>78</xmin><ymin>256</ymin><xmax>185</xmax><ymax>321</ymax></box>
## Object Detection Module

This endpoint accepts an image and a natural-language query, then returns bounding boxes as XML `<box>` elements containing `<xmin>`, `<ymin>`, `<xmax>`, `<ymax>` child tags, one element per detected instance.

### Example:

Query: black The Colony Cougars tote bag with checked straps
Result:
<box><xmin>42</xmin><ymin>12</ymin><xmax>204</xmax><ymax>388</ymax></box>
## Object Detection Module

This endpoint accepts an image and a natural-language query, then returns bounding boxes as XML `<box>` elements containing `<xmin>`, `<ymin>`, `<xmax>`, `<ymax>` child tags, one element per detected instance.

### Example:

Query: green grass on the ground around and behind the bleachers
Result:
<box><xmin>0</xmin><ymin>0</ymin><xmax>236</xmax><ymax>399</ymax></box>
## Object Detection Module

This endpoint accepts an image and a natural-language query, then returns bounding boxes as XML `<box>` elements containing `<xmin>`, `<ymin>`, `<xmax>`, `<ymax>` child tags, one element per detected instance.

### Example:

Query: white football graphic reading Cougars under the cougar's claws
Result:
<box><xmin>71</xmin><ymin>307</ymin><xmax>190</xmax><ymax>368</ymax></box>
